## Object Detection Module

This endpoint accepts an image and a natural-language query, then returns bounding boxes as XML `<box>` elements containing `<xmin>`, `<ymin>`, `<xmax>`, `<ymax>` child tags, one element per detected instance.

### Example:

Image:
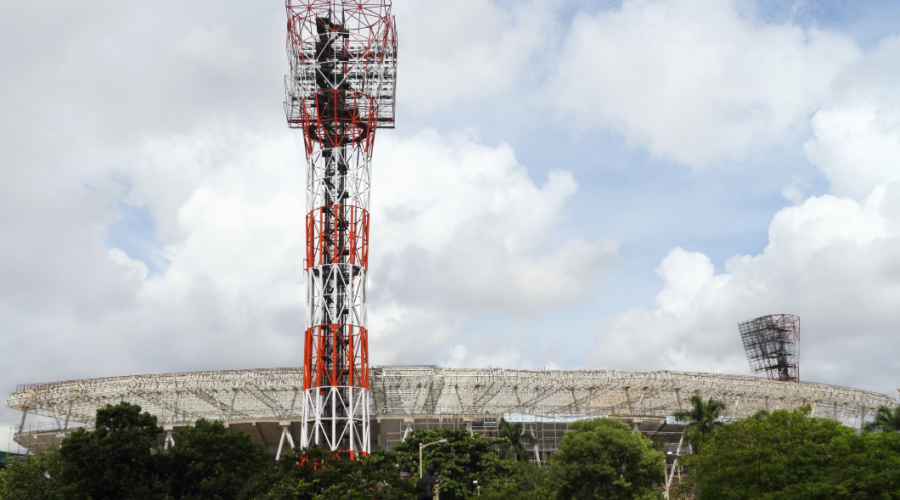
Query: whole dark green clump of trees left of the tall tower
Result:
<box><xmin>0</xmin><ymin>403</ymin><xmax>272</xmax><ymax>500</ymax></box>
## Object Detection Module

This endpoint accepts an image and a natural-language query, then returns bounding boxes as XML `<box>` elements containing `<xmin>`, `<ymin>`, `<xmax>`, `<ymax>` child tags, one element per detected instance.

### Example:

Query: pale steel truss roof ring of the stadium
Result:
<box><xmin>7</xmin><ymin>366</ymin><xmax>896</xmax><ymax>432</ymax></box>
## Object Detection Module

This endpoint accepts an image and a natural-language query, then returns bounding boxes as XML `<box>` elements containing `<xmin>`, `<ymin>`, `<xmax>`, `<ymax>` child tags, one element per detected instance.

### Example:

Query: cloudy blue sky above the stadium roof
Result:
<box><xmin>0</xmin><ymin>0</ymin><xmax>900</xmax><ymax>448</ymax></box>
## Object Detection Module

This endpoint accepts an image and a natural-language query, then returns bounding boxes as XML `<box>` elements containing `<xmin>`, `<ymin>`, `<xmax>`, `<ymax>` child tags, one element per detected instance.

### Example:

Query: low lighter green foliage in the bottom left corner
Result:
<box><xmin>0</xmin><ymin>450</ymin><xmax>64</xmax><ymax>500</ymax></box>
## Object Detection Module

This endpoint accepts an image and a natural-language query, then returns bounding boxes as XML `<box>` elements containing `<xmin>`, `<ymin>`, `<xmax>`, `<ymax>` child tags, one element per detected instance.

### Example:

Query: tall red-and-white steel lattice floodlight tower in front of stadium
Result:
<box><xmin>285</xmin><ymin>0</ymin><xmax>397</xmax><ymax>458</ymax></box>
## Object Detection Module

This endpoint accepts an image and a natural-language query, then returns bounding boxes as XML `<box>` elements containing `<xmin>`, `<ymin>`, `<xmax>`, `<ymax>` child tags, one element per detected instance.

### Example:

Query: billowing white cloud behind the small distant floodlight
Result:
<box><xmin>592</xmin><ymin>188</ymin><xmax>900</xmax><ymax>392</ymax></box>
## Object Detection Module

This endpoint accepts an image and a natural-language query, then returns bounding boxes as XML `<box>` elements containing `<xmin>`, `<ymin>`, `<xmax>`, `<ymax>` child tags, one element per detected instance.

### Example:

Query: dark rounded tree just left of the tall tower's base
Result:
<box><xmin>167</xmin><ymin>419</ymin><xmax>272</xmax><ymax>499</ymax></box>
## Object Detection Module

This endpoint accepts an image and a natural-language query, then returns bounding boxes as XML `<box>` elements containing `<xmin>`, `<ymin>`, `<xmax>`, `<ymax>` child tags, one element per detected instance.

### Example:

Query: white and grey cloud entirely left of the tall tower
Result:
<box><xmin>0</xmin><ymin>130</ymin><xmax>305</xmax><ymax>390</ymax></box>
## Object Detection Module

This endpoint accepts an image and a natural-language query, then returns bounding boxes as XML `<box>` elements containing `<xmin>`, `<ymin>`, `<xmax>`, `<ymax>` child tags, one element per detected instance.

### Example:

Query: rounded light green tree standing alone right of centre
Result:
<box><xmin>547</xmin><ymin>418</ymin><xmax>665</xmax><ymax>499</ymax></box>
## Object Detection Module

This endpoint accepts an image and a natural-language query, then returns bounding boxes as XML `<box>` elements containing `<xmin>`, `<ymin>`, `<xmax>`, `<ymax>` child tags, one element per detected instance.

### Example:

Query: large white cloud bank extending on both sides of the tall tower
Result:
<box><xmin>0</xmin><ymin>122</ymin><xmax>617</xmax><ymax>410</ymax></box>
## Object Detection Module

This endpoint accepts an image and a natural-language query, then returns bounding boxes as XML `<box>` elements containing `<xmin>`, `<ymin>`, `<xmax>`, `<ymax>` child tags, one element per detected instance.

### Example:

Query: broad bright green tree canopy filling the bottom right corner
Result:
<box><xmin>687</xmin><ymin>407</ymin><xmax>900</xmax><ymax>499</ymax></box>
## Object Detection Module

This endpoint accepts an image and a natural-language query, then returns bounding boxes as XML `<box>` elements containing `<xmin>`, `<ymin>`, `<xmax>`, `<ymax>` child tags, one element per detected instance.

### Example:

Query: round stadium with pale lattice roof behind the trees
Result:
<box><xmin>7</xmin><ymin>366</ymin><xmax>896</xmax><ymax>461</ymax></box>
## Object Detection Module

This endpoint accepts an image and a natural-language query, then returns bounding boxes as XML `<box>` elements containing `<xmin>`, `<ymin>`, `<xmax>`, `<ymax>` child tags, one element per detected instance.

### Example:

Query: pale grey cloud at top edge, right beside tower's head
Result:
<box><xmin>394</xmin><ymin>0</ymin><xmax>559</xmax><ymax>113</ymax></box>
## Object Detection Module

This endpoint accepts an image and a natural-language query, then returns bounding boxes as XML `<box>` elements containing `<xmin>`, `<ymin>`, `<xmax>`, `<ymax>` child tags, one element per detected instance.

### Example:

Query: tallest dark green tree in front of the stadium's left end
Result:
<box><xmin>59</xmin><ymin>402</ymin><xmax>166</xmax><ymax>500</ymax></box>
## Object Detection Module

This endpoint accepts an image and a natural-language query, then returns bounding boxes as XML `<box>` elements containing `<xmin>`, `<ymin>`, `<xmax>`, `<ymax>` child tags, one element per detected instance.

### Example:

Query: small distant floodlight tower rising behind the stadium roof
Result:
<box><xmin>738</xmin><ymin>314</ymin><xmax>800</xmax><ymax>382</ymax></box>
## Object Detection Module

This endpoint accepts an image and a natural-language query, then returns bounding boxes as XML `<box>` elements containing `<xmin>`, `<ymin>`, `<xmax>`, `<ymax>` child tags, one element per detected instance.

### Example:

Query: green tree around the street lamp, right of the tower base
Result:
<box><xmin>393</xmin><ymin>428</ymin><xmax>514</xmax><ymax>500</ymax></box>
